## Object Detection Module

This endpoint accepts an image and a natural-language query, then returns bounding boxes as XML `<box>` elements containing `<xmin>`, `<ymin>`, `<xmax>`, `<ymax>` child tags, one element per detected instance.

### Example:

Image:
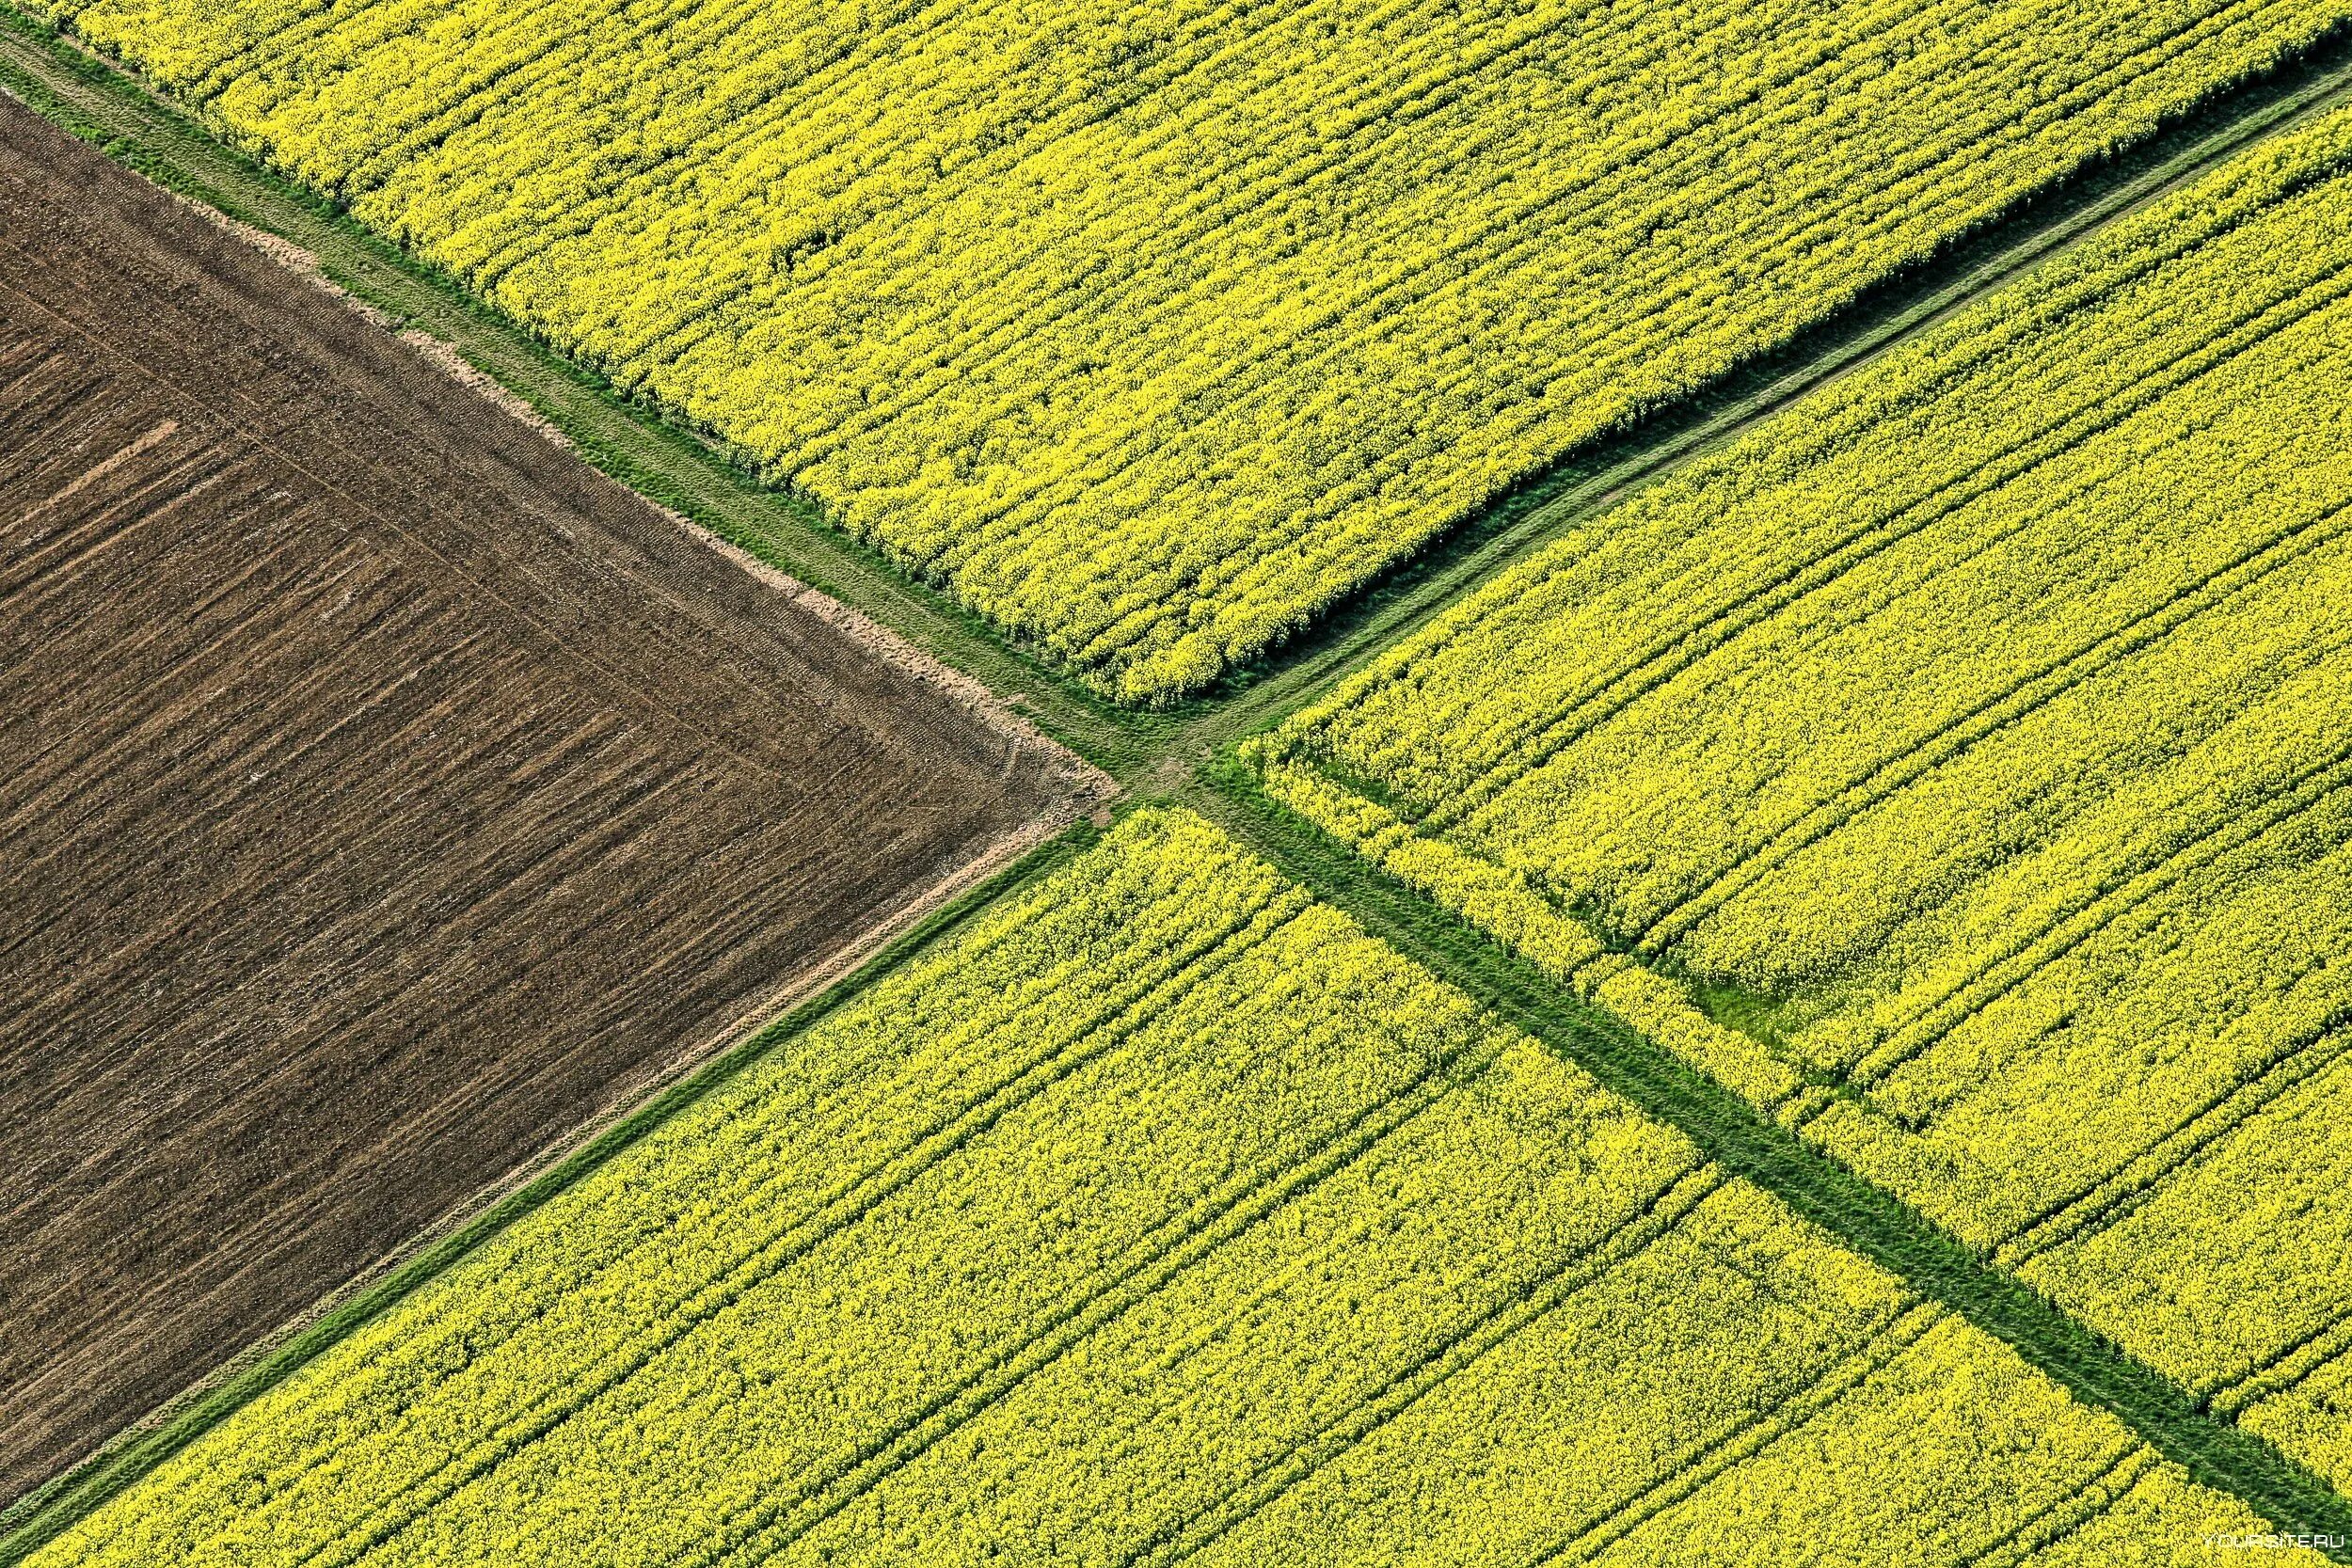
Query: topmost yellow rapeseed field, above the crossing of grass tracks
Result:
<box><xmin>52</xmin><ymin>0</ymin><xmax>2347</xmax><ymax>701</ymax></box>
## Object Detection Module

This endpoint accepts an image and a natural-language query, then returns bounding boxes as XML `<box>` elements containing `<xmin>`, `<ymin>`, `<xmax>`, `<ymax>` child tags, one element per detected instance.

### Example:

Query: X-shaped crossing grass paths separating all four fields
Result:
<box><xmin>0</xmin><ymin>0</ymin><xmax>2352</xmax><ymax>1568</ymax></box>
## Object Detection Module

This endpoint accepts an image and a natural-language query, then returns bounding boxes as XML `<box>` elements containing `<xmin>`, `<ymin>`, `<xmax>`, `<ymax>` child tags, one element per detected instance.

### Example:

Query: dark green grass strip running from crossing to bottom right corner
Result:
<box><xmin>1185</xmin><ymin>752</ymin><xmax>2352</xmax><ymax>1561</ymax></box>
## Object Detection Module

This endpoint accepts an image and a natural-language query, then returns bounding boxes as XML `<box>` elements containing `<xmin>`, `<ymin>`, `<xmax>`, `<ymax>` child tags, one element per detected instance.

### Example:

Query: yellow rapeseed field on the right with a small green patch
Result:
<box><xmin>1261</xmin><ymin>113</ymin><xmax>2352</xmax><ymax>1481</ymax></box>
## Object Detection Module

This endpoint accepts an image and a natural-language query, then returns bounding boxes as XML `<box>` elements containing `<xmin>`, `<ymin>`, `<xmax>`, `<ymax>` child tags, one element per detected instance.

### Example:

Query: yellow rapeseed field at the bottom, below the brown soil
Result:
<box><xmin>33</xmin><ymin>811</ymin><xmax>2261</xmax><ymax>1568</ymax></box>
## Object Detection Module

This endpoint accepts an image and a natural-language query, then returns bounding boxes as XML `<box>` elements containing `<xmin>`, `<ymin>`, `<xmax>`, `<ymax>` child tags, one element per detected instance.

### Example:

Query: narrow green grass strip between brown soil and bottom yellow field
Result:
<box><xmin>0</xmin><ymin>820</ymin><xmax>1101</xmax><ymax>1568</ymax></box>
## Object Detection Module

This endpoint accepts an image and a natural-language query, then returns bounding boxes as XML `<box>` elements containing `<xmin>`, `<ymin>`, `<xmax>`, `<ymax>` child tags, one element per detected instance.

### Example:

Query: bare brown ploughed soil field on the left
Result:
<box><xmin>0</xmin><ymin>99</ymin><xmax>1101</xmax><ymax>1500</ymax></box>
